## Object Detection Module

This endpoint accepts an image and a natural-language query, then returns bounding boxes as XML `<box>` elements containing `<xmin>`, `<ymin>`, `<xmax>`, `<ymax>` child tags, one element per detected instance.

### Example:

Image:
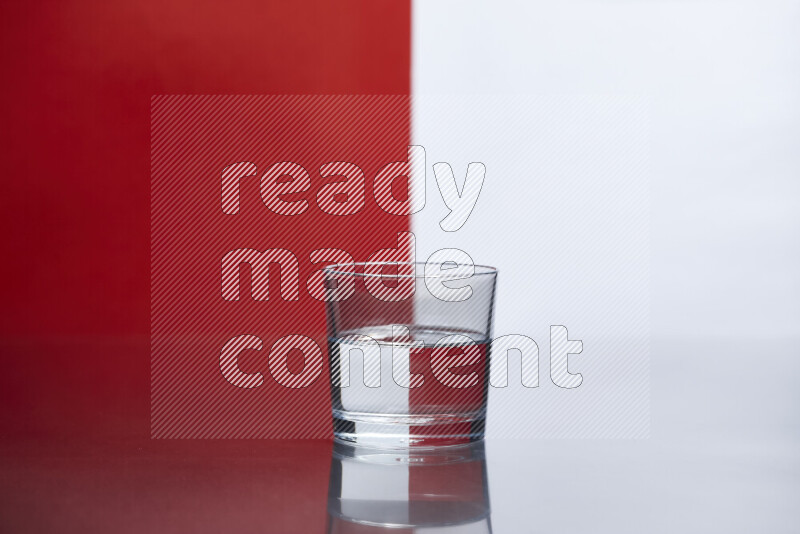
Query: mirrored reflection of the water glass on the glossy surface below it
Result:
<box><xmin>328</xmin><ymin>441</ymin><xmax>492</xmax><ymax>534</ymax></box>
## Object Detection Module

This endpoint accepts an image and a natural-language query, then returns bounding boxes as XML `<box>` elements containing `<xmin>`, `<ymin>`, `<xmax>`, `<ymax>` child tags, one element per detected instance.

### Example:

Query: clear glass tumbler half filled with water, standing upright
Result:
<box><xmin>323</xmin><ymin>262</ymin><xmax>497</xmax><ymax>448</ymax></box>
